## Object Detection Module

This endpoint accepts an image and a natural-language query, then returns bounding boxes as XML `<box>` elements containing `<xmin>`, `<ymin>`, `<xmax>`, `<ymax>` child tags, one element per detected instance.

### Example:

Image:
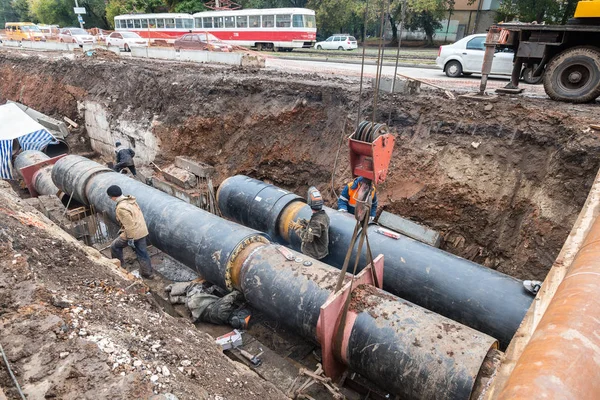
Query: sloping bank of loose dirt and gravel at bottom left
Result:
<box><xmin>0</xmin><ymin>182</ymin><xmax>284</xmax><ymax>399</ymax></box>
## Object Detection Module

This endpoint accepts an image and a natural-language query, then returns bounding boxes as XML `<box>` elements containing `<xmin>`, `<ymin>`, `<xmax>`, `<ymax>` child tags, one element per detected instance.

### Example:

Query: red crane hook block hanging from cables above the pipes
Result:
<box><xmin>348</xmin><ymin>133</ymin><xmax>396</xmax><ymax>184</ymax></box>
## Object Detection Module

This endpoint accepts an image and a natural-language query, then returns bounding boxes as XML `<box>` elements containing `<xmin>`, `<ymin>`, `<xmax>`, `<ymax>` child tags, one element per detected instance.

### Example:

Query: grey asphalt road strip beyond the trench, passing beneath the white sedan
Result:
<box><xmin>266</xmin><ymin>57</ymin><xmax>545</xmax><ymax>96</ymax></box>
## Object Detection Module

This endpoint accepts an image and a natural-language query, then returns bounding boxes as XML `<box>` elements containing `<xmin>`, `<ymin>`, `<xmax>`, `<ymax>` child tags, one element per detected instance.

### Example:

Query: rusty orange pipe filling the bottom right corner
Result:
<box><xmin>498</xmin><ymin>212</ymin><xmax>600</xmax><ymax>400</ymax></box>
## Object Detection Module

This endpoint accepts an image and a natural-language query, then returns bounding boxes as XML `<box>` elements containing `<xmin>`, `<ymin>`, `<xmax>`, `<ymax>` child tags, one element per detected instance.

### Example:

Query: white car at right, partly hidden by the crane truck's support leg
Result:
<box><xmin>435</xmin><ymin>34</ymin><xmax>542</xmax><ymax>84</ymax></box>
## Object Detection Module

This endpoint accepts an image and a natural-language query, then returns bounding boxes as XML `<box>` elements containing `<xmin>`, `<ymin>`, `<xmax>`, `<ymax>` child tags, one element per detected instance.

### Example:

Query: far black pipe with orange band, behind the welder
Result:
<box><xmin>217</xmin><ymin>175</ymin><xmax>533</xmax><ymax>349</ymax></box>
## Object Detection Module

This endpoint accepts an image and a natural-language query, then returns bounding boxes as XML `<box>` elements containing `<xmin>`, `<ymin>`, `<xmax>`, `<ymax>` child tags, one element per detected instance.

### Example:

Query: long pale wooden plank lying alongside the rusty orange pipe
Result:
<box><xmin>480</xmin><ymin>165</ymin><xmax>600</xmax><ymax>400</ymax></box>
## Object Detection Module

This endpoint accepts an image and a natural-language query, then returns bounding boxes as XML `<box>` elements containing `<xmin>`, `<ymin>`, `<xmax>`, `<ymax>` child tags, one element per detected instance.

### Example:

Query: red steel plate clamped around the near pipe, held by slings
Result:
<box><xmin>317</xmin><ymin>254</ymin><xmax>383</xmax><ymax>381</ymax></box>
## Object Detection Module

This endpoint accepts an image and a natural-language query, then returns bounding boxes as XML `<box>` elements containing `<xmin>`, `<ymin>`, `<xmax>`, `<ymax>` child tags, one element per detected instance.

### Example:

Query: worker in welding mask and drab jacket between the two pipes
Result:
<box><xmin>294</xmin><ymin>186</ymin><xmax>329</xmax><ymax>260</ymax></box>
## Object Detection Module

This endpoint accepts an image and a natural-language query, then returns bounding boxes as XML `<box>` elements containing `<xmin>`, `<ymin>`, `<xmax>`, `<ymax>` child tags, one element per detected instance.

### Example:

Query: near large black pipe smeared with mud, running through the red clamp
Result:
<box><xmin>52</xmin><ymin>155</ymin><xmax>497</xmax><ymax>399</ymax></box>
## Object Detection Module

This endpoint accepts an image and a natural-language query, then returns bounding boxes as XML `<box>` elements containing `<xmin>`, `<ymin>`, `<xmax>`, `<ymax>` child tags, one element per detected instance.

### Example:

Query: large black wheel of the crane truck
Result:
<box><xmin>544</xmin><ymin>47</ymin><xmax>600</xmax><ymax>103</ymax></box>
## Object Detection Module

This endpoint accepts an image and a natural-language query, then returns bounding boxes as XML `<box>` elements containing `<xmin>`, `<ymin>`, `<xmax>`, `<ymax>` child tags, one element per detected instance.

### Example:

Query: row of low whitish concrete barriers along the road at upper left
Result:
<box><xmin>2</xmin><ymin>40</ymin><xmax>265</xmax><ymax>68</ymax></box>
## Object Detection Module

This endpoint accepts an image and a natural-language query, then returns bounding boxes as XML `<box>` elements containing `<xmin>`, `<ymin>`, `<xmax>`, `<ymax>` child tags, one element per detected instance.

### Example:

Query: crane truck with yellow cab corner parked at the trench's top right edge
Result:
<box><xmin>488</xmin><ymin>0</ymin><xmax>600</xmax><ymax>103</ymax></box>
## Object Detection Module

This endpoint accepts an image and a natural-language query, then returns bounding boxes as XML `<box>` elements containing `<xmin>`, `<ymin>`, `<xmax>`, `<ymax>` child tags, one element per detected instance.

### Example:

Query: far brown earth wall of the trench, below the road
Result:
<box><xmin>0</xmin><ymin>52</ymin><xmax>600</xmax><ymax>279</ymax></box>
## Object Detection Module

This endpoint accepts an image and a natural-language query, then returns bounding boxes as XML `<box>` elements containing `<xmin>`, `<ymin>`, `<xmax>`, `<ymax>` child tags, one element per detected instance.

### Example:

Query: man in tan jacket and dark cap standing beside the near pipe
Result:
<box><xmin>106</xmin><ymin>185</ymin><xmax>152</xmax><ymax>279</ymax></box>
